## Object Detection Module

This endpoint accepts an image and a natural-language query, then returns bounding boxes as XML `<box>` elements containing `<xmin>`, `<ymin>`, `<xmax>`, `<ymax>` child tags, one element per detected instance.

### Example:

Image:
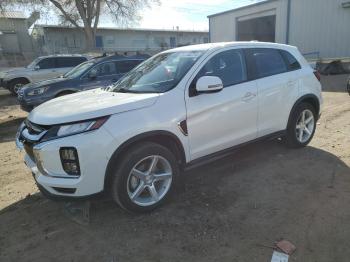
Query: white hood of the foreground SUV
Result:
<box><xmin>28</xmin><ymin>89</ymin><xmax>159</xmax><ymax>125</ymax></box>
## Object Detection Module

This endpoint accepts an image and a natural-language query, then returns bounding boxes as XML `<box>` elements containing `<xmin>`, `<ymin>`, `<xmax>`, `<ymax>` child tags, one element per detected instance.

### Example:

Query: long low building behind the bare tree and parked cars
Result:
<box><xmin>32</xmin><ymin>24</ymin><xmax>209</xmax><ymax>54</ymax></box>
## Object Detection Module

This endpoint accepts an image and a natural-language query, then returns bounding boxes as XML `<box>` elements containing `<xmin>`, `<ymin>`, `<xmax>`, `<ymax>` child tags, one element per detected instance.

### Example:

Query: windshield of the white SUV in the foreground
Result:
<box><xmin>111</xmin><ymin>51</ymin><xmax>203</xmax><ymax>93</ymax></box>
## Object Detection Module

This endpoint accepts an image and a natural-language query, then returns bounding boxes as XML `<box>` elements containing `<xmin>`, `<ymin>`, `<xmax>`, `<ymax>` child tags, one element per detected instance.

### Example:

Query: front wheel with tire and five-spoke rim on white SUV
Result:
<box><xmin>107</xmin><ymin>142</ymin><xmax>180</xmax><ymax>213</ymax></box>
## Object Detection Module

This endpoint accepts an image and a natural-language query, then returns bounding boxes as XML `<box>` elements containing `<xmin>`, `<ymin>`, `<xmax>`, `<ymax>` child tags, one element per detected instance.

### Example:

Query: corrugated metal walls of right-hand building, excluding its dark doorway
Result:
<box><xmin>209</xmin><ymin>0</ymin><xmax>350</xmax><ymax>58</ymax></box>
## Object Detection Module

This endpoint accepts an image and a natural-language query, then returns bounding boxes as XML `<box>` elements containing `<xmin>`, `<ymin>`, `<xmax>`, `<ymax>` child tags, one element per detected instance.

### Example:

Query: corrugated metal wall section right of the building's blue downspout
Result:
<box><xmin>290</xmin><ymin>0</ymin><xmax>350</xmax><ymax>58</ymax></box>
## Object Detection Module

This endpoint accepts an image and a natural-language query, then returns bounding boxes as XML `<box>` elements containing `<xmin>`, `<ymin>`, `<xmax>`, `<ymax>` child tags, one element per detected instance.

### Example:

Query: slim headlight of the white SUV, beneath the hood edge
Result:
<box><xmin>43</xmin><ymin>116</ymin><xmax>109</xmax><ymax>141</ymax></box>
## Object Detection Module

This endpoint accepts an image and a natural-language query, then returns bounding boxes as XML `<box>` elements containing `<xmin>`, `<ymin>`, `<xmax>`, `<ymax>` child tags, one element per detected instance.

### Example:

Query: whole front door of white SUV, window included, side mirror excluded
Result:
<box><xmin>186</xmin><ymin>49</ymin><xmax>258</xmax><ymax>160</ymax></box>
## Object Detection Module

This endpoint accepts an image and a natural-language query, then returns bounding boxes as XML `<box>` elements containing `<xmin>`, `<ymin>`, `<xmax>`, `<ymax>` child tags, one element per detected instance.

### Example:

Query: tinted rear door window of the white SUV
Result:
<box><xmin>251</xmin><ymin>49</ymin><xmax>287</xmax><ymax>78</ymax></box>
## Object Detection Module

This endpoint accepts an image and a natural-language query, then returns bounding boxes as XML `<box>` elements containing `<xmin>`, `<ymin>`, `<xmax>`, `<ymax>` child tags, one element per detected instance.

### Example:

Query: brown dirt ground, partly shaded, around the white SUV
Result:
<box><xmin>0</xmin><ymin>76</ymin><xmax>350</xmax><ymax>262</ymax></box>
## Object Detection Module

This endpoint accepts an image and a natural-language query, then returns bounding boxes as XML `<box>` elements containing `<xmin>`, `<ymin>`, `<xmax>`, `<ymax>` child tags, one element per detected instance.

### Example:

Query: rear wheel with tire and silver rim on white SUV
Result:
<box><xmin>285</xmin><ymin>103</ymin><xmax>317</xmax><ymax>148</ymax></box>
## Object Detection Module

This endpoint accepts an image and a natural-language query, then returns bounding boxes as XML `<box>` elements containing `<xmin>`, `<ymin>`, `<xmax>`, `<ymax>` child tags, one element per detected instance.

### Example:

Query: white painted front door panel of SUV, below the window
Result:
<box><xmin>186</xmin><ymin>81</ymin><xmax>258</xmax><ymax>160</ymax></box>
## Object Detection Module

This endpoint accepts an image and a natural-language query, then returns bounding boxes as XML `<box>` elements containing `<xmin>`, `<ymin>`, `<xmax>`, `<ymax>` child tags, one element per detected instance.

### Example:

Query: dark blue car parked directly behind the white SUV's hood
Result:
<box><xmin>18</xmin><ymin>56</ymin><xmax>145</xmax><ymax>112</ymax></box>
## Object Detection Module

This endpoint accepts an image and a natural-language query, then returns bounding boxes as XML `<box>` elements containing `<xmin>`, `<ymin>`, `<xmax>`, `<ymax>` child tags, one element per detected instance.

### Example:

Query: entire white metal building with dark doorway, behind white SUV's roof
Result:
<box><xmin>208</xmin><ymin>0</ymin><xmax>350</xmax><ymax>58</ymax></box>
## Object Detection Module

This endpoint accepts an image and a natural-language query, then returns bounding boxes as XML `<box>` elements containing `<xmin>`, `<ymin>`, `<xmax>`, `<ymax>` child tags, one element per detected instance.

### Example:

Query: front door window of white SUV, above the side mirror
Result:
<box><xmin>196</xmin><ymin>50</ymin><xmax>247</xmax><ymax>87</ymax></box>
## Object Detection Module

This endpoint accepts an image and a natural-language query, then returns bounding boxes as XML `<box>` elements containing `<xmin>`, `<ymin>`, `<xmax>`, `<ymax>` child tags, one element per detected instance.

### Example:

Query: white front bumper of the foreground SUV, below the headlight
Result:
<box><xmin>16</xmin><ymin>122</ymin><xmax>116</xmax><ymax>199</ymax></box>
